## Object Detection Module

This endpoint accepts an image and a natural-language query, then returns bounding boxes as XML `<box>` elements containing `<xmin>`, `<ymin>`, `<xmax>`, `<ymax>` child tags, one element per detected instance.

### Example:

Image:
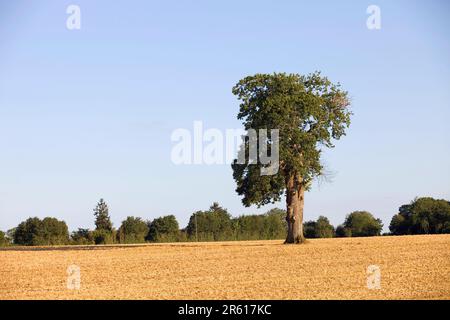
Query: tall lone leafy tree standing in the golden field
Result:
<box><xmin>232</xmin><ymin>72</ymin><xmax>351</xmax><ymax>243</ymax></box>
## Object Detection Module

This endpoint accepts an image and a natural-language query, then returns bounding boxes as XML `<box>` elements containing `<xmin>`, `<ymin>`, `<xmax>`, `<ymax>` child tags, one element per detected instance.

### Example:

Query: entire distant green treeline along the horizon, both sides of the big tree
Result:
<box><xmin>0</xmin><ymin>198</ymin><xmax>450</xmax><ymax>246</ymax></box>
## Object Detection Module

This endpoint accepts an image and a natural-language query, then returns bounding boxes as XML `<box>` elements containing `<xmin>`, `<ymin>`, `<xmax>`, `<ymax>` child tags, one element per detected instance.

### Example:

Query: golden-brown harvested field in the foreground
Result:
<box><xmin>0</xmin><ymin>235</ymin><xmax>450</xmax><ymax>299</ymax></box>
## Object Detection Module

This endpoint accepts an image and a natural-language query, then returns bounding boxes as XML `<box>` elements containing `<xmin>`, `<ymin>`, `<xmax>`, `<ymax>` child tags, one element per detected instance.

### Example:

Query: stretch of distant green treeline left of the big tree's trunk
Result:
<box><xmin>0</xmin><ymin>199</ymin><xmax>286</xmax><ymax>246</ymax></box>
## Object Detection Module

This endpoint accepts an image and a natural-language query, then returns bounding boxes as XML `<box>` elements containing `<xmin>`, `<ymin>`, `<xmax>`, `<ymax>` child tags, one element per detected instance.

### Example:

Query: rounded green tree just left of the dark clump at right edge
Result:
<box><xmin>344</xmin><ymin>211</ymin><xmax>383</xmax><ymax>237</ymax></box>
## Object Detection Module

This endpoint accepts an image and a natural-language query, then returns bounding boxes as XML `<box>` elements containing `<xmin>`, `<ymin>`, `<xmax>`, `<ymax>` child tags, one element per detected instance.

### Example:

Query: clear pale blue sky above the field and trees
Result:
<box><xmin>0</xmin><ymin>0</ymin><xmax>450</xmax><ymax>230</ymax></box>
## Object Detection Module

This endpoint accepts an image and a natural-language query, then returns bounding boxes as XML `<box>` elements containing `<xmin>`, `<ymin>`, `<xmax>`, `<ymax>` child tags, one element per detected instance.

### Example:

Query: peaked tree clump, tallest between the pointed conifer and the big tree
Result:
<box><xmin>186</xmin><ymin>202</ymin><xmax>233</xmax><ymax>241</ymax></box>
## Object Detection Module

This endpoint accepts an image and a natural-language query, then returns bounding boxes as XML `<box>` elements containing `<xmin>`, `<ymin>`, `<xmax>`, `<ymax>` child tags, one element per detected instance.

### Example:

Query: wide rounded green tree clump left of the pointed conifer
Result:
<box><xmin>13</xmin><ymin>217</ymin><xmax>69</xmax><ymax>246</ymax></box>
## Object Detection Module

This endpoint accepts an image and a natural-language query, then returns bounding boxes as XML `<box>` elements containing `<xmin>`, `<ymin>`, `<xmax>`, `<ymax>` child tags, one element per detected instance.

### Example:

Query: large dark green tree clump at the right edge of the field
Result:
<box><xmin>389</xmin><ymin>197</ymin><xmax>450</xmax><ymax>235</ymax></box>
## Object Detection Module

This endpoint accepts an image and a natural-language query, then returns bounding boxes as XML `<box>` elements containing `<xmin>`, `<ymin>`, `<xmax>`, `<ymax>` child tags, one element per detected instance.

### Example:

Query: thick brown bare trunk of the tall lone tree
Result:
<box><xmin>284</xmin><ymin>176</ymin><xmax>305</xmax><ymax>243</ymax></box>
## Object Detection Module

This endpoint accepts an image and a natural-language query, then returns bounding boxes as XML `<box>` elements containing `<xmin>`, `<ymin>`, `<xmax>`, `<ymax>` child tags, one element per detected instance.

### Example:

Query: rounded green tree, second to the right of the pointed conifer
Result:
<box><xmin>146</xmin><ymin>215</ymin><xmax>180</xmax><ymax>242</ymax></box>
